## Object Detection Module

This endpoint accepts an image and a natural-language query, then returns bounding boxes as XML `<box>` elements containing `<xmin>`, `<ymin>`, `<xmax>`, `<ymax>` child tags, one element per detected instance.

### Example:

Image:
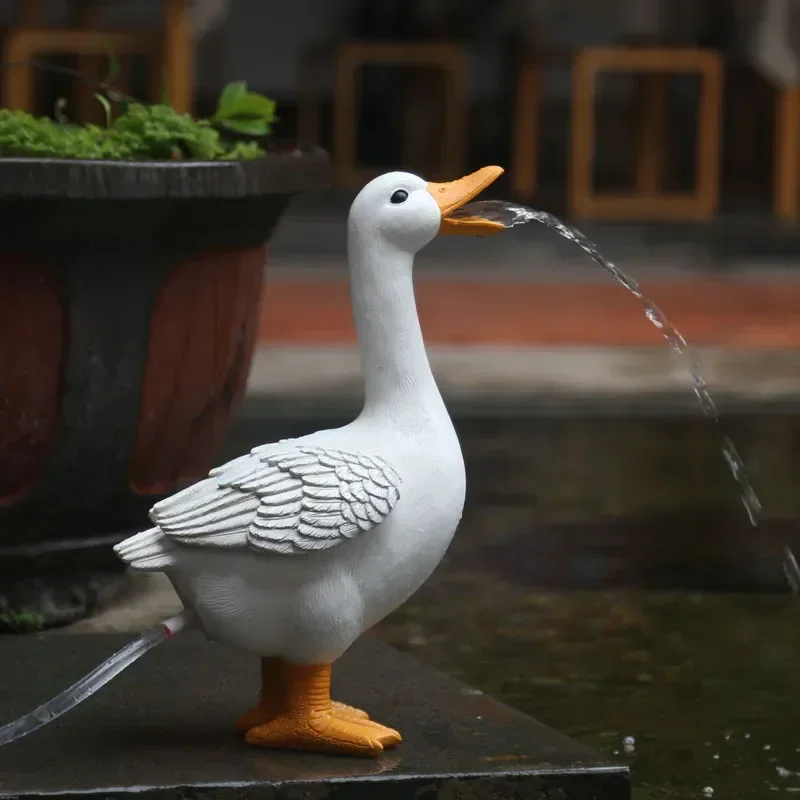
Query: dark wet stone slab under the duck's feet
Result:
<box><xmin>0</xmin><ymin>633</ymin><xmax>630</xmax><ymax>800</ymax></box>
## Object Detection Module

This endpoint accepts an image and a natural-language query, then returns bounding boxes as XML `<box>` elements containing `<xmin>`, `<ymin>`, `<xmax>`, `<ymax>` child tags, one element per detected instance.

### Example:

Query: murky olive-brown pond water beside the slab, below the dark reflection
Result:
<box><xmin>378</xmin><ymin>570</ymin><xmax>800</xmax><ymax>800</ymax></box>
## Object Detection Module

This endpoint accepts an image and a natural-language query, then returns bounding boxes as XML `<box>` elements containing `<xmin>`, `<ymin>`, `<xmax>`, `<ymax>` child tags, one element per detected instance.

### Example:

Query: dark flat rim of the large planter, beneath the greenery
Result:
<box><xmin>0</xmin><ymin>148</ymin><xmax>330</xmax><ymax>200</ymax></box>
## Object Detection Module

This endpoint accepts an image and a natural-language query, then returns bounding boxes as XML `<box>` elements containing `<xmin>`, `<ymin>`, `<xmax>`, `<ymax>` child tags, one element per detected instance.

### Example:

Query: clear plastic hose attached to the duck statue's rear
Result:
<box><xmin>0</xmin><ymin>611</ymin><xmax>193</xmax><ymax>747</ymax></box>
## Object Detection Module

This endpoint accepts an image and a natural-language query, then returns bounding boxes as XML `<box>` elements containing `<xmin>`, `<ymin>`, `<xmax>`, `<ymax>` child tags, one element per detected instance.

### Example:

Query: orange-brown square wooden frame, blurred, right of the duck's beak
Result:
<box><xmin>568</xmin><ymin>47</ymin><xmax>723</xmax><ymax>221</ymax></box>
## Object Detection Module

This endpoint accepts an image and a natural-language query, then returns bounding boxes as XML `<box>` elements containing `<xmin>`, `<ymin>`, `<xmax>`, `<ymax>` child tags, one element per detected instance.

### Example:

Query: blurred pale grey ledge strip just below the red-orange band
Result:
<box><xmin>248</xmin><ymin>347</ymin><xmax>800</xmax><ymax>413</ymax></box>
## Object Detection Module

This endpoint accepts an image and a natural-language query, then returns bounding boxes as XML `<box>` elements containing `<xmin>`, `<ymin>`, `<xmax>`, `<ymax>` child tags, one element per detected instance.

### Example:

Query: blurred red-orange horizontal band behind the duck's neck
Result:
<box><xmin>260</xmin><ymin>277</ymin><xmax>800</xmax><ymax>349</ymax></box>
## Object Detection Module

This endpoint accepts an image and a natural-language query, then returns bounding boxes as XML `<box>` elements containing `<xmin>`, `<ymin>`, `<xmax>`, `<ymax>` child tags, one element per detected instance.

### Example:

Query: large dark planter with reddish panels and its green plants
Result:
<box><xmin>0</xmin><ymin>73</ymin><xmax>329</xmax><ymax>630</ymax></box>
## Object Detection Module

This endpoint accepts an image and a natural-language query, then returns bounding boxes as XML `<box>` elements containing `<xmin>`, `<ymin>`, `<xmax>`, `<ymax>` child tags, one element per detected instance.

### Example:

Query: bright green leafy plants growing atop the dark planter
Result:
<box><xmin>0</xmin><ymin>82</ymin><xmax>276</xmax><ymax>161</ymax></box>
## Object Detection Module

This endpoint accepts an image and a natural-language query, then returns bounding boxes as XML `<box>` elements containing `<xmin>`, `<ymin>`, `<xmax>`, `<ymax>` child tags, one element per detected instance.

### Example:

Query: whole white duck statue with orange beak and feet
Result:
<box><xmin>111</xmin><ymin>167</ymin><xmax>503</xmax><ymax>756</ymax></box>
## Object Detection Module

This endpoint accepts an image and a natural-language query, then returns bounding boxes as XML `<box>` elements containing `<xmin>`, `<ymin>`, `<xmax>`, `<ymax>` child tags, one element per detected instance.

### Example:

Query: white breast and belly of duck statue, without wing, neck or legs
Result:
<box><xmin>160</xmin><ymin>412</ymin><xmax>465</xmax><ymax>664</ymax></box>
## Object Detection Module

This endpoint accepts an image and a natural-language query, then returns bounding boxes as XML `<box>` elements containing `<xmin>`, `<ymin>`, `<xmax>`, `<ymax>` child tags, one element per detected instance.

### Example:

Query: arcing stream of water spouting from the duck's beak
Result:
<box><xmin>453</xmin><ymin>200</ymin><xmax>800</xmax><ymax>594</ymax></box>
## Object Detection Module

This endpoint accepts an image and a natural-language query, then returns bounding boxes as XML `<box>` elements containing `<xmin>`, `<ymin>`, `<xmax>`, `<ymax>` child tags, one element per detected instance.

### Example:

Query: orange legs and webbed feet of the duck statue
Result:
<box><xmin>237</xmin><ymin>664</ymin><xmax>402</xmax><ymax>756</ymax></box>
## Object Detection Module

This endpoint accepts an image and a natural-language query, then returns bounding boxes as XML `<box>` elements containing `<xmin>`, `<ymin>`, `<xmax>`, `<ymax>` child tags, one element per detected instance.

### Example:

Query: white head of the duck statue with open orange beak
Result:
<box><xmin>348</xmin><ymin>167</ymin><xmax>504</xmax><ymax>255</ymax></box>
